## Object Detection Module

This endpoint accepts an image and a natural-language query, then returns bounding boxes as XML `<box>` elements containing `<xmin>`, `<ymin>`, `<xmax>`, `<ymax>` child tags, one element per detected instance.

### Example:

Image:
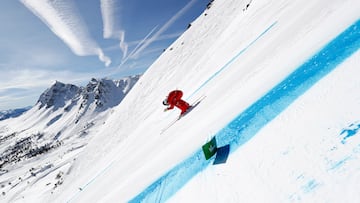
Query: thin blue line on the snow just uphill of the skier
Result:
<box><xmin>187</xmin><ymin>21</ymin><xmax>278</xmax><ymax>100</ymax></box>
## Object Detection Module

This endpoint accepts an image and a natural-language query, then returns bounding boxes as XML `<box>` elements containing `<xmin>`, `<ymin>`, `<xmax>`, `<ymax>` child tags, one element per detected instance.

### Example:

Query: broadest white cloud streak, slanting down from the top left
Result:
<box><xmin>21</xmin><ymin>0</ymin><xmax>111</xmax><ymax>66</ymax></box>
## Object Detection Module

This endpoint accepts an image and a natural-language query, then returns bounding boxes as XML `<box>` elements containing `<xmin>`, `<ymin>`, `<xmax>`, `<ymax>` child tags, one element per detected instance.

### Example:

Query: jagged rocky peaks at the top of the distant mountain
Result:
<box><xmin>37</xmin><ymin>75</ymin><xmax>140</xmax><ymax>111</ymax></box>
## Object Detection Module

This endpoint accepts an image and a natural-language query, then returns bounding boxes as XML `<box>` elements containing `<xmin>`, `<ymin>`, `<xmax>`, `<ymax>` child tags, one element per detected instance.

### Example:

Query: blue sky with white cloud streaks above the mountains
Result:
<box><xmin>0</xmin><ymin>0</ymin><xmax>208</xmax><ymax>110</ymax></box>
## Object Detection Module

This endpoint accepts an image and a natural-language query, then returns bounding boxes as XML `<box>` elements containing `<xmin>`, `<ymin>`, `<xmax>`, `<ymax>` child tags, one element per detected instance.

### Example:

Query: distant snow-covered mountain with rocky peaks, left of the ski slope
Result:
<box><xmin>0</xmin><ymin>75</ymin><xmax>140</xmax><ymax>201</ymax></box>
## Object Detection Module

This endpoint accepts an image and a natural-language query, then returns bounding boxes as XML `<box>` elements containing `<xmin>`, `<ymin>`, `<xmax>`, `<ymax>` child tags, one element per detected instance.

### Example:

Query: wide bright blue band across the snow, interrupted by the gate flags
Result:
<box><xmin>129</xmin><ymin>19</ymin><xmax>360</xmax><ymax>203</ymax></box>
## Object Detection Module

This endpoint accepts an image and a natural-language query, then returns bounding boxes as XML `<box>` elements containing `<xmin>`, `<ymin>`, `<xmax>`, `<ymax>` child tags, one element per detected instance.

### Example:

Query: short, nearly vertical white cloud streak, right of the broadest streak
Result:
<box><xmin>100</xmin><ymin>0</ymin><xmax>128</xmax><ymax>58</ymax></box>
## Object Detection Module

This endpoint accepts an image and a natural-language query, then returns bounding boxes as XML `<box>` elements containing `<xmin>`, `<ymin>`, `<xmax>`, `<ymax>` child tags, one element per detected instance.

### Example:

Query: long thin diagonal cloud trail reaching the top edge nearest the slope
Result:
<box><xmin>129</xmin><ymin>0</ymin><xmax>196</xmax><ymax>59</ymax></box>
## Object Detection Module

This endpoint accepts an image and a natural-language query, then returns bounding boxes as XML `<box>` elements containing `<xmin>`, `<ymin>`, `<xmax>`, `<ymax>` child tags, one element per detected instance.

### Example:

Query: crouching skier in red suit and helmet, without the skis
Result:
<box><xmin>163</xmin><ymin>90</ymin><xmax>190</xmax><ymax>116</ymax></box>
